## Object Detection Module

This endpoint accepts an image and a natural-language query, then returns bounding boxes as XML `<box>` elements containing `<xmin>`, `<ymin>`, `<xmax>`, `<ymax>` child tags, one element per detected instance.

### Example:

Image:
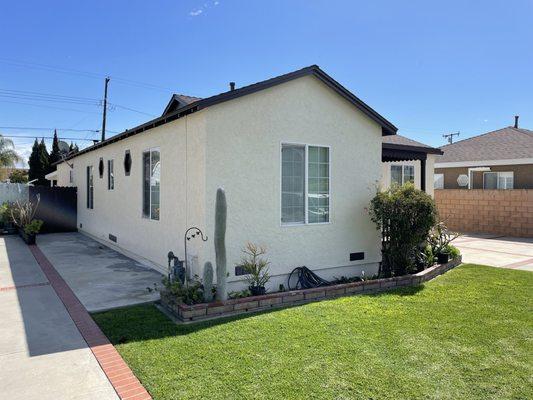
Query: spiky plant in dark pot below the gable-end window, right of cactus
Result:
<box><xmin>240</xmin><ymin>243</ymin><xmax>270</xmax><ymax>296</ymax></box>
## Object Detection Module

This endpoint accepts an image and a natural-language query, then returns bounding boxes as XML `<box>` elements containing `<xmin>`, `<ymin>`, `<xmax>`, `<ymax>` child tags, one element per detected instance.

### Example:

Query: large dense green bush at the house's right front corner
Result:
<box><xmin>370</xmin><ymin>183</ymin><xmax>437</xmax><ymax>276</ymax></box>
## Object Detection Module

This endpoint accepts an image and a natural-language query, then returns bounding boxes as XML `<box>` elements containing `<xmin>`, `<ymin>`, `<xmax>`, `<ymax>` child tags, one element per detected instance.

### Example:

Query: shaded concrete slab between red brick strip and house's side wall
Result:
<box><xmin>37</xmin><ymin>232</ymin><xmax>162</xmax><ymax>312</ymax></box>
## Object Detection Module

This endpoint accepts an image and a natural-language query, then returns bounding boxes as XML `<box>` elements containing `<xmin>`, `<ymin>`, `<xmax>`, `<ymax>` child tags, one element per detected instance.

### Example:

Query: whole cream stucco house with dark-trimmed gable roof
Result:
<box><xmin>51</xmin><ymin>66</ymin><xmax>432</xmax><ymax>290</ymax></box>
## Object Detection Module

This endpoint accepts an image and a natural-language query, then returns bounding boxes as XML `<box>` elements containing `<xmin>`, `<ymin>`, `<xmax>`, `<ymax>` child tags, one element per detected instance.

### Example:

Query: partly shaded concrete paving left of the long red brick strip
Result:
<box><xmin>0</xmin><ymin>236</ymin><xmax>118</xmax><ymax>400</ymax></box>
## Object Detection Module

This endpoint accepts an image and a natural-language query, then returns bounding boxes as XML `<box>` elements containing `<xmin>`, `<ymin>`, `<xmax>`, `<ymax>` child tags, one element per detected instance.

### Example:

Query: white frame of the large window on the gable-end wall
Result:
<box><xmin>278</xmin><ymin>141</ymin><xmax>332</xmax><ymax>227</ymax></box>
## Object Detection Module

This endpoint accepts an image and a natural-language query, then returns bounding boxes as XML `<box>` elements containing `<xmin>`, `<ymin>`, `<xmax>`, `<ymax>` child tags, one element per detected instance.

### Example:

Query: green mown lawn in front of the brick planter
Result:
<box><xmin>94</xmin><ymin>265</ymin><xmax>533</xmax><ymax>399</ymax></box>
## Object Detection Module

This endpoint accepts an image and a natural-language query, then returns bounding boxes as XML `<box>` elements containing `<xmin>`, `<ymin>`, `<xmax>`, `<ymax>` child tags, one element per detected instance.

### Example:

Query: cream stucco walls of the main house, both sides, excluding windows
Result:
<box><xmin>58</xmin><ymin>76</ymin><xmax>382</xmax><ymax>290</ymax></box>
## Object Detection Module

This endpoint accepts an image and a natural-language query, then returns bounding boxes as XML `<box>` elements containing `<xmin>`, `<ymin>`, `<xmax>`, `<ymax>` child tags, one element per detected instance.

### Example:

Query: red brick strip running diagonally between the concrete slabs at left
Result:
<box><xmin>28</xmin><ymin>245</ymin><xmax>152</xmax><ymax>400</ymax></box>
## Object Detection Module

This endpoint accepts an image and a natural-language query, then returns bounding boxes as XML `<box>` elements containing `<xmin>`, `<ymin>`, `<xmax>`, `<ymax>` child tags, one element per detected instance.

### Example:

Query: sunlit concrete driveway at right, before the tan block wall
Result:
<box><xmin>453</xmin><ymin>234</ymin><xmax>533</xmax><ymax>271</ymax></box>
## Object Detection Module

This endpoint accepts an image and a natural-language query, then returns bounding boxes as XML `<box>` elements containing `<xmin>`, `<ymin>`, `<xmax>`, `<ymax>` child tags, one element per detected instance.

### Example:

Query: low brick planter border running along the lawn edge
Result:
<box><xmin>161</xmin><ymin>257</ymin><xmax>461</xmax><ymax>323</ymax></box>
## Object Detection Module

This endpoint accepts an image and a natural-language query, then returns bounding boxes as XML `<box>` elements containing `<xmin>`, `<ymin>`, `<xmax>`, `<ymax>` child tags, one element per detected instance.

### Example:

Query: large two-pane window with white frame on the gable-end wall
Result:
<box><xmin>281</xmin><ymin>144</ymin><xmax>330</xmax><ymax>224</ymax></box>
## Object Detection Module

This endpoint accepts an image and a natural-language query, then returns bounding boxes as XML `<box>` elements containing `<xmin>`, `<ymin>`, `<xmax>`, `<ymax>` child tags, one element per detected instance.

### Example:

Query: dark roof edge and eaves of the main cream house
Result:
<box><xmin>60</xmin><ymin>65</ymin><xmax>398</xmax><ymax>164</ymax></box>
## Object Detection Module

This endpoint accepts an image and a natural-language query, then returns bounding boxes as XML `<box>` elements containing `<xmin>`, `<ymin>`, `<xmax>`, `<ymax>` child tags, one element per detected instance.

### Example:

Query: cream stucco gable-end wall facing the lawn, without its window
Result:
<box><xmin>201</xmin><ymin>76</ymin><xmax>381</xmax><ymax>290</ymax></box>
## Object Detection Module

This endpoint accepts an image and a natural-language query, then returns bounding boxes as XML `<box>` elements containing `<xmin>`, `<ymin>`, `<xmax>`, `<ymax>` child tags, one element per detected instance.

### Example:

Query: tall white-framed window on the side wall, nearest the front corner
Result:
<box><xmin>143</xmin><ymin>149</ymin><xmax>161</xmax><ymax>220</ymax></box>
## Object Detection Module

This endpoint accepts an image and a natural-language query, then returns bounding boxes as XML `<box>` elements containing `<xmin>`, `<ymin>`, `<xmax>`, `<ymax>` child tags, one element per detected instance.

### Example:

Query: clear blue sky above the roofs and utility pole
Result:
<box><xmin>0</xmin><ymin>0</ymin><xmax>533</xmax><ymax>163</ymax></box>
